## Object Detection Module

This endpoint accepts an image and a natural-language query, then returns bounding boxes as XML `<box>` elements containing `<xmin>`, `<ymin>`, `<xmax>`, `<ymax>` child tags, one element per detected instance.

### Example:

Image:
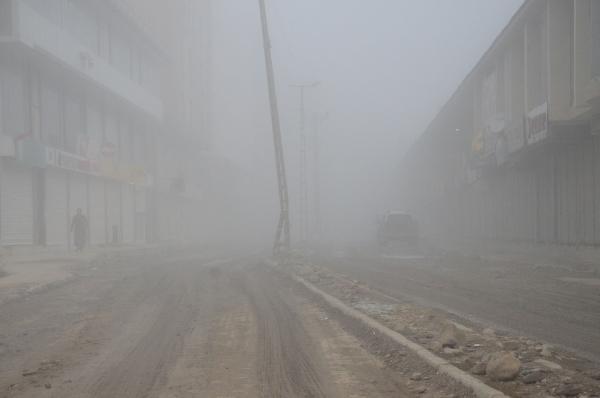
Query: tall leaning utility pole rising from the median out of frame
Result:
<box><xmin>258</xmin><ymin>0</ymin><xmax>290</xmax><ymax>256</ymax></box>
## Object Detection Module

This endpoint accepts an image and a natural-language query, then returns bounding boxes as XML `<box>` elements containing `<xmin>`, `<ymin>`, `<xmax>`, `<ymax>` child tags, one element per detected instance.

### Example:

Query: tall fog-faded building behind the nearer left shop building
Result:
<box><xmin>114</xmin><ymin>0</ymin><xmax>210</xmax><ymax>243</ymax></box>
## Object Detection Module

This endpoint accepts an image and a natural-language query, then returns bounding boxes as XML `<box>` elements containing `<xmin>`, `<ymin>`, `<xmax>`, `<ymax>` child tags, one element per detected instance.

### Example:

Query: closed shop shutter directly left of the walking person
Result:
<box><xmin>44</xmin><ymin>169</ymin><xmax>68</xmax><ymax>245</ymax></box>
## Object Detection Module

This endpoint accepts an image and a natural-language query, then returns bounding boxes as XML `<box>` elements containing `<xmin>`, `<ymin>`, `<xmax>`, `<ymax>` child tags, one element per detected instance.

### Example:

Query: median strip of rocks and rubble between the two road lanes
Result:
<box><xmin>294</xmin><ymin>264</ymin><xmax>600</xmax><ymax>398</ymax></box>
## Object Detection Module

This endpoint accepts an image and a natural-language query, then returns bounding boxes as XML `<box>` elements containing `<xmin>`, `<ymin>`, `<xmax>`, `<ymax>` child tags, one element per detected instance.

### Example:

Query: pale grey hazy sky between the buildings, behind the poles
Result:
<box><xmin>207</xmin><ymin>0</ymin><xmax>523</xmax><ymax>244</ymax></box>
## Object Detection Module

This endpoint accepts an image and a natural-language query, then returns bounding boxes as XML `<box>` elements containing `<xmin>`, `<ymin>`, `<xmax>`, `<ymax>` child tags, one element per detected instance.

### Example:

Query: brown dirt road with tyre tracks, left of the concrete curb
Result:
<box><xmin>0</xmin><ymin>252</ymin><xmax>462</xmax><ymax>398</ymax></box>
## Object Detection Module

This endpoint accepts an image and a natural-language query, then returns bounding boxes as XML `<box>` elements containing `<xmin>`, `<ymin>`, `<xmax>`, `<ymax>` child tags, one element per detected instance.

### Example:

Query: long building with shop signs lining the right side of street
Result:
<box><xmin>401</xmin><ymin>0</ymin><xmax>600</xmax><ymax>244</ymax></box>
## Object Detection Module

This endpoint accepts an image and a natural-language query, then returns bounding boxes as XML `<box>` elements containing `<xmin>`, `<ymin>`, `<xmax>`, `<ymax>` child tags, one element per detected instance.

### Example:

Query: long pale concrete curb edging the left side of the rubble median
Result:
<box><xmin>292</xmin><ymin>275</ymin><xmax>510</xmax><ymax>398</ymax></box>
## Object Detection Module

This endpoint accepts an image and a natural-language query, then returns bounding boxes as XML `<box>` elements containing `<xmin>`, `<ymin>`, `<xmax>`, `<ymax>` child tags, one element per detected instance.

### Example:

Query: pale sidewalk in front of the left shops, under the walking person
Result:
<box><xmin>0</xmin><ymin>245</ymin><xmax>155</xmax><ymax>305</ymax></box>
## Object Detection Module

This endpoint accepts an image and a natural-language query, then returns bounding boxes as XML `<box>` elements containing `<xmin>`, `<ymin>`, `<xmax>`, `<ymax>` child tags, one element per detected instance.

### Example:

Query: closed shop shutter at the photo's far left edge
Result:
<box><xmin>1</xmin><ymin>166</ymin><xmax>33</xmax><ymax>245</ymax></box>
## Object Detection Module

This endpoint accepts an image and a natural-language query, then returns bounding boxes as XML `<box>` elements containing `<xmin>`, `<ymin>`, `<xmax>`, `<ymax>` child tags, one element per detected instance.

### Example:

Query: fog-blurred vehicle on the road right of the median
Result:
<box><xmin>377</xmin><ymin>211</ymin><xmax>419</xmax><ymax>246</ymax></box>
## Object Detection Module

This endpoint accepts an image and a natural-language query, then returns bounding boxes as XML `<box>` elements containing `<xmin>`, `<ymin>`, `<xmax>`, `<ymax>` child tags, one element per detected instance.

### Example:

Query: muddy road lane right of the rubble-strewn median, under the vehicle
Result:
<box><xmin>318</xmin><ymin>253</ymin><xmax>600</xmax><ymax>361</ymax></box>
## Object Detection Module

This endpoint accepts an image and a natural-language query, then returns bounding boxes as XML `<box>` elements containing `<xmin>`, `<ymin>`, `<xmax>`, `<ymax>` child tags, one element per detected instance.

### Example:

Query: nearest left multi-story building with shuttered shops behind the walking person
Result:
<box><xmin>0</xmin><ymin>0</ymin><xmax>173</xmax><ymax>246</ymax></box>
